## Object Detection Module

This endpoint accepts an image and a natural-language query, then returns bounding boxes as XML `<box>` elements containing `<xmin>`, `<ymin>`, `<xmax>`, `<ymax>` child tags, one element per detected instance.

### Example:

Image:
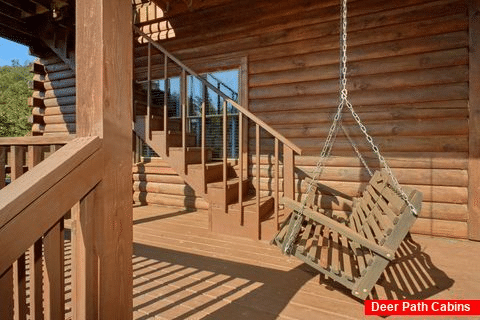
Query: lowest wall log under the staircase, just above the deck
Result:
<box><xmin>133</xmin><ymin>192</ymin><xmax>208</xmax><ymax>210</ymax></box>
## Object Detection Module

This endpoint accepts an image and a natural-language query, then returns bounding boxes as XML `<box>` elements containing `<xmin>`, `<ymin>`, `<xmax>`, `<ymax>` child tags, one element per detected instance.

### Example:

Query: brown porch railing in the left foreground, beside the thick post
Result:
<box><xmin>0</xmin><ymin>137</ymin><xmax>103</xmax><ymax>319</ymax></box>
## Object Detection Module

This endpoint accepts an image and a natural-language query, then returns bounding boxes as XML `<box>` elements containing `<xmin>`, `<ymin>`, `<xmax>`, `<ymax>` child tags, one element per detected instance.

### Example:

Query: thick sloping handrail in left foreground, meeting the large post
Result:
<box><xmin>0</xmin><ymin>137</ymin><xmax>103</xmax><ymax>274</ymax></box>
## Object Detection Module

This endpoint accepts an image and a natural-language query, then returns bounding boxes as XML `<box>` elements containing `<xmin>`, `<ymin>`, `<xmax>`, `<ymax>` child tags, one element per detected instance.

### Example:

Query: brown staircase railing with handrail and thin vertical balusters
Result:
<box><xmin>134</xmin><ymin>26</ymin><xmax>302</xmax><ymax>230</ymax></box>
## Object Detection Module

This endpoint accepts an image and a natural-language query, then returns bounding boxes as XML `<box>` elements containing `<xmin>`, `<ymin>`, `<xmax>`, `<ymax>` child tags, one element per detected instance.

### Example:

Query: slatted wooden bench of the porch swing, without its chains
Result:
<box><xmin>273</xmin><ymin>170</ymin><xmax>422</xmax><ymax>299</ymax></box>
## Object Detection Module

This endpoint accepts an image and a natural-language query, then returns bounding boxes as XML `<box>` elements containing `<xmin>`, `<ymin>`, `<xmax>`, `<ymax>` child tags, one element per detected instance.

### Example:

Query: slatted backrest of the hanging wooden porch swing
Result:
<box><xmin>347</xmin><ymin>169</ymin><xmax>422</xmax><ymax>250</ymax></box>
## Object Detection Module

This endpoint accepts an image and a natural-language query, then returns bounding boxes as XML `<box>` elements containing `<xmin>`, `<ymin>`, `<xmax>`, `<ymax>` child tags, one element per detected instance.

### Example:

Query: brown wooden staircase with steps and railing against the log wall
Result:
<box><xmin>134</xmin><ymin>28</ymin><xmax>301</xmax><ymax>239</ymax></box>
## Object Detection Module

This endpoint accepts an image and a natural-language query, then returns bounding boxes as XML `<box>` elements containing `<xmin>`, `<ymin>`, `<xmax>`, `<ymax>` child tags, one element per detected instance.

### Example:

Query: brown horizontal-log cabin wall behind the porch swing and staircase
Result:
<box><xmin>135</xmin><ymin>0</ymin><xmax>469</xmax><ymax>238</ymax></box>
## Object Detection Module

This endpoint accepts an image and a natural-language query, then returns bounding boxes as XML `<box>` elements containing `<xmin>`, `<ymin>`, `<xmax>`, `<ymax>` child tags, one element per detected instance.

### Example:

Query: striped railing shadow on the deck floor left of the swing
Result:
<box><xmin>134</xmin><ymin>243</ymin><xmax>316</xmax><ymax>320</ymax></box>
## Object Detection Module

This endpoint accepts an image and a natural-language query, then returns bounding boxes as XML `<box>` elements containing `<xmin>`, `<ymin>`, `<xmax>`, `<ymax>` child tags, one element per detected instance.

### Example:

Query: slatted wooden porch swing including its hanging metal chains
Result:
<box><xmin>272</xmin><ymin>0</ymin><xmax>422</xmax><ymax>300</ymax></box>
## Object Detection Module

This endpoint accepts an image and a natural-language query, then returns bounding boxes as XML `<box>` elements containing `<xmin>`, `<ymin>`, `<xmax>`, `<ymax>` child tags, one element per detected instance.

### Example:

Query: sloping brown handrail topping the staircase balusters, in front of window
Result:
<box><xmin>133</xmin><ymin>26</ymin><xmax>302</xmax><ymax>154</ymax></box>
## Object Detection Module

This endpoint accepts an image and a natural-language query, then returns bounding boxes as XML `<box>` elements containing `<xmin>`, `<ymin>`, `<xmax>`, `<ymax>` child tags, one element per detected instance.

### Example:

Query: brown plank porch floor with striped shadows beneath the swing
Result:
<box><xmin>127</xmin><ymin>206</ymin><xmax>480</xmax><ymax>320</ymax></box>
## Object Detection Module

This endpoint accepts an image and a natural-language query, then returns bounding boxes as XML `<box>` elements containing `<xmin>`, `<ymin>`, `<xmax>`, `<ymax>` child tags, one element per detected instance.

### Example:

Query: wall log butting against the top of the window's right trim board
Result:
<box><xmin>248</xmin><ymin>31</ymin><xmax>468</xmax><ymax>75</ymax></box>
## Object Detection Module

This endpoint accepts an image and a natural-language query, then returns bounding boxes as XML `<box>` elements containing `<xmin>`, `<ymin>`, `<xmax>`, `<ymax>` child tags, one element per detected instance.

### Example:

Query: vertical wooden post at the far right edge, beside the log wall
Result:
<box><xmin>468</xmin><ymin>0</ymin><xmax>480</xmax><ymax>240</ymax></box>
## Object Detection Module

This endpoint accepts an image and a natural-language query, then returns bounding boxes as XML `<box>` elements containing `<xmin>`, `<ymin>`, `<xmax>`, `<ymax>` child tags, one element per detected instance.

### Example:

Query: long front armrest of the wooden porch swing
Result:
<box><xmin>280</xmin><ymin>198</ymin><xmax>395</xmax><ymax>260</ymax></box>
